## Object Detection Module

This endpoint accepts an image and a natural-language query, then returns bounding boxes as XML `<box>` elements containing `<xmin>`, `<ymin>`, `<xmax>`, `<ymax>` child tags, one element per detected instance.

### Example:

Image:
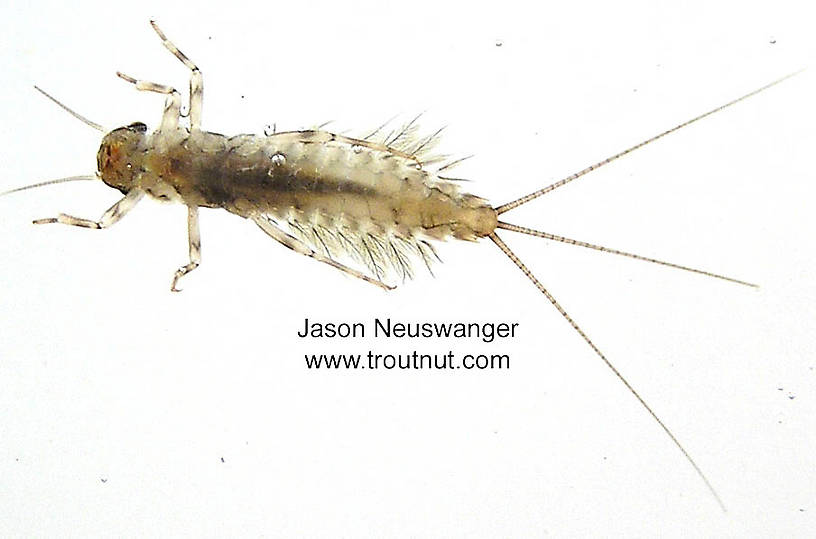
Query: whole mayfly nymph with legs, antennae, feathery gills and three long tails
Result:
<box><xmin>2</xmin><ymin>21</ymin><xmax>791</xmax><ymax>508</ymax></box>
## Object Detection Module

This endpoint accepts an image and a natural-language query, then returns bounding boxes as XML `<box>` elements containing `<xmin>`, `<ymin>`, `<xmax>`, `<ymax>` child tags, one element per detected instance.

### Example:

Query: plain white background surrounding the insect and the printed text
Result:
<box><xmin>0</xmin><ymin>2</ymin><xmax>816</xmax><ymax>537</ymax></box>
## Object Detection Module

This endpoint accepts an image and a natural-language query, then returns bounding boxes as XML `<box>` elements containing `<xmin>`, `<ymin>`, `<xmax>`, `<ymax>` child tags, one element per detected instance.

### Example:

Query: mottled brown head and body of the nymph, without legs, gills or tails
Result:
<box><xmin>99</xmin><ymin>124</ymin><xmax>497</xmax><ymax>246</ymax></box>
